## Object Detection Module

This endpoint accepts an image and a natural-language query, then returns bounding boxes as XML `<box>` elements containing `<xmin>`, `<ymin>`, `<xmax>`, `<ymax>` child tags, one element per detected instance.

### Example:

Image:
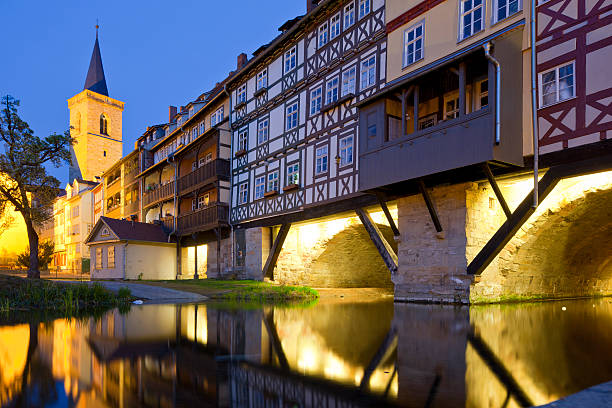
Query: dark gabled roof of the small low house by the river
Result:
<box><xmin>85</xmin><ymin>217</ymin><xmax>168</xmax><ymax>244</ymax></box>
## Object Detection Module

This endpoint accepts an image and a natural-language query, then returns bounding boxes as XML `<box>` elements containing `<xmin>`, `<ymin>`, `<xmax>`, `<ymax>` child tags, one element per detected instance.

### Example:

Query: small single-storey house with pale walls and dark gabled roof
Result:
<box><xmin>85</xmin><ymin>217</ymin><xmax>177</xmax><ymax>280</ymax></box>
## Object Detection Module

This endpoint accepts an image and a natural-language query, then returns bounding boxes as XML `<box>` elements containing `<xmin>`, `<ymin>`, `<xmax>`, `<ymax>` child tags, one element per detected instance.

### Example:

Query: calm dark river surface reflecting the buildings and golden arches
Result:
<box><xmin>0</xmin><ymin>299</ymin><xmax>612</xmax><ymax>408</ymax></box>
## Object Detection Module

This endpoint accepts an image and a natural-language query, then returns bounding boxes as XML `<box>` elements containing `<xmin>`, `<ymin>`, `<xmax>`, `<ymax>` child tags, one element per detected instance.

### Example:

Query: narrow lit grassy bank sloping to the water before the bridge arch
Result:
<box><xmin>131</xmin><ymin>279</ymin><xmax>319</xmax><ymax>304</ymax></box>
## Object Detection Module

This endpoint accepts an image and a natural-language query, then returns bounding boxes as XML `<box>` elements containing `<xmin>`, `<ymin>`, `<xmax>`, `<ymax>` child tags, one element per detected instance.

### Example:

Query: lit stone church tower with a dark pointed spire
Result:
<box><xmin>68</xmin><ymin>26</ymin><xmax>124</xmax><ymax>183</ymax></box>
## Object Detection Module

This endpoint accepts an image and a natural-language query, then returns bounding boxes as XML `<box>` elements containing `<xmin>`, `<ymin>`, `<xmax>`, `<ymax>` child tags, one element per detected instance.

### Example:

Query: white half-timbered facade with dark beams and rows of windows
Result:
<box><xmin>227</xmin><ymin>0</ymin><xmax>386</xmax><ymax>223</ymax></box>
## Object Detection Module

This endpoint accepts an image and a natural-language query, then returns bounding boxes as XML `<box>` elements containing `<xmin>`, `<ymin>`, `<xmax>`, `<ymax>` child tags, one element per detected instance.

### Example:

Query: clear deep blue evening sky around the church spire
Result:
<box><xmin>0</xmin><ymin>0</ymin><xmax>306</xmax><ymax>185</ymax></box>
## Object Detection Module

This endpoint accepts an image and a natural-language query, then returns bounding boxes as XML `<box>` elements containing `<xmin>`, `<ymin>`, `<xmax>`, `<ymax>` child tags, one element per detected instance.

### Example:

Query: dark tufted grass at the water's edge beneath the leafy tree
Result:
<box><xmin>0</xmin><ymin>275</ymin><xmax>132</xmax><ymax>316</ymax></box>
